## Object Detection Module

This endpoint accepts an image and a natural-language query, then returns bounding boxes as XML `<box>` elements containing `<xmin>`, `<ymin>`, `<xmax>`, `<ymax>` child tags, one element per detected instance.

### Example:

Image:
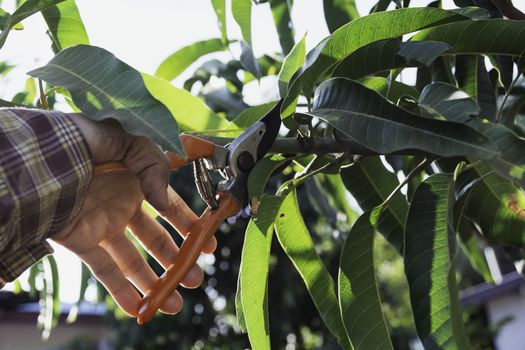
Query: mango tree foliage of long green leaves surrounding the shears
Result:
<box><xmin>5</xmin><ymin>0</ymin><xmax>525</xmax><ymax>350</ymax></box>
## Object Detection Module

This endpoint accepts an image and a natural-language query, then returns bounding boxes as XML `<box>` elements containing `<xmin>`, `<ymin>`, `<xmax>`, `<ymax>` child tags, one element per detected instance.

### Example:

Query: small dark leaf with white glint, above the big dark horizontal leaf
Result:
<box><xmin>418</xmin><ymin>82</ymin><xmax>480</xmax><ymax>122</ymax></box>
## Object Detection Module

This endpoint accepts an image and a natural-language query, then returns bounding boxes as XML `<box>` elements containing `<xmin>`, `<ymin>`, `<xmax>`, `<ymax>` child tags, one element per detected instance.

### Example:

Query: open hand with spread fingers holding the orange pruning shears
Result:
<box><xmin>52</xmin><ymin>115</ymin><xmax>216</xmax><ymax>316</ymax></box>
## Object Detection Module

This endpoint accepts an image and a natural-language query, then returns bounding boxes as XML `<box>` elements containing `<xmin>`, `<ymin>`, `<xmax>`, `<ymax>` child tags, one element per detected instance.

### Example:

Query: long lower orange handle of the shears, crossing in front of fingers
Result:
<box><xmin>137</xmin><ymin>192</ymin><xmax>241</xmax><ymax>324</ymax></box>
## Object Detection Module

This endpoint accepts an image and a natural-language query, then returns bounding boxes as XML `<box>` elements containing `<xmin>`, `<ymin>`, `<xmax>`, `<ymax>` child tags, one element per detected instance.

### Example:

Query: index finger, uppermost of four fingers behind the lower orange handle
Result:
<box><xmin>160</xmin><ymin>187</ymin><xmax>217</xmax><ymax>254</ymax></box>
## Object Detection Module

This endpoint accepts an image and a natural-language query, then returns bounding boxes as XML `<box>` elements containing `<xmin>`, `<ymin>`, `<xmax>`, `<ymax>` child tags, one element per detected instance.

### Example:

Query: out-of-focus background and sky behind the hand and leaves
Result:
<box><xmin>0</xmin><ymin>0</ymin><xmax>525</xmax><ymax>350</ymax></box>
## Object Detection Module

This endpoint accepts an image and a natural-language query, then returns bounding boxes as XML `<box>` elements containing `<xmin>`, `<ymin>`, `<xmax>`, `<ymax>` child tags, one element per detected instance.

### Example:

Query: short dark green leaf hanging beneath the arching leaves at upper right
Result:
<box><xmin>456</xmin><ymin>55</ymin><xmax>497</xmax><ymax>120</ymax></box>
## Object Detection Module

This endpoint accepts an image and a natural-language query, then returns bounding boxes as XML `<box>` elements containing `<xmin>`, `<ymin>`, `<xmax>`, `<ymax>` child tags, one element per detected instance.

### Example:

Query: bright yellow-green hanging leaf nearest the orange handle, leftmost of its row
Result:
<box><xmin>240</xmin><ymin>197</ymin><xmax>282</xmax><ymax>350</ymax></box>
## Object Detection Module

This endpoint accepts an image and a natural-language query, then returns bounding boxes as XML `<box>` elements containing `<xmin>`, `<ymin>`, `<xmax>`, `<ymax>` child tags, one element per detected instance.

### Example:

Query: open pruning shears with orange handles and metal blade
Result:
<box><xmin>94</xmin><ymin>103</ymin><xmax>281</xmax><ymax>324</ymax></box>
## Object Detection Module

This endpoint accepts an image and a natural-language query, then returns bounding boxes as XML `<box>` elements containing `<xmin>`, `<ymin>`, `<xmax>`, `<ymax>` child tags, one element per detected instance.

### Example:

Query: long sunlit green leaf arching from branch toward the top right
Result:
<box><xmin>281</xmin><ymin>8</ymin><xmax>465</xmax><ymax>118</ymax></box>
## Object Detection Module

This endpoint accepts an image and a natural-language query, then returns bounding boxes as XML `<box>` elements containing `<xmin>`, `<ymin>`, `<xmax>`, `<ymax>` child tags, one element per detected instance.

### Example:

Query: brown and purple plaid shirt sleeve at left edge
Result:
<box><xmin>0</xmin><ymin>108</ymin><xmax>93</xmax><ymax>288</ymax></box>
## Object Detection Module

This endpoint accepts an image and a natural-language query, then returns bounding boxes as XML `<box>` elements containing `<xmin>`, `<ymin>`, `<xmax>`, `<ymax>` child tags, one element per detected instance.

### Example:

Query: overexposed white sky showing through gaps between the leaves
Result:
<box><xmin>0</xmin><ymin>0</ymin><xmax>525</xmax><ymax>302</ymax></box>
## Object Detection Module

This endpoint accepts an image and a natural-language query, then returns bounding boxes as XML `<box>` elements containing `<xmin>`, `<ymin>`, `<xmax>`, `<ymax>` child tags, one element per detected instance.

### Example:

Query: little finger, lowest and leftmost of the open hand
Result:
<box><xmin>78</xmin><ymin>246</ymin><xmax>141</xmax><ymax>317</ymax></box>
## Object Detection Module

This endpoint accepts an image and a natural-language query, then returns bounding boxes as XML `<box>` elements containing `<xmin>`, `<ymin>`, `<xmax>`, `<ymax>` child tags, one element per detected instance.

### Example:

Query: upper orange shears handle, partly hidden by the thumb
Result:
<box><xmin>93</xmin><ymin>134</ymin><xmax>215</xmax><ymax>176</ymax></box>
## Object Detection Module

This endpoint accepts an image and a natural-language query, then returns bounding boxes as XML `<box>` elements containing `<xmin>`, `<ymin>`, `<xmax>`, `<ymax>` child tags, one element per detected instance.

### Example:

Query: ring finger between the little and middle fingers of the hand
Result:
<box><xmin>101</xmin><ymin>234</ymin><xmax>182</xmax><ymax>314</ymax></box>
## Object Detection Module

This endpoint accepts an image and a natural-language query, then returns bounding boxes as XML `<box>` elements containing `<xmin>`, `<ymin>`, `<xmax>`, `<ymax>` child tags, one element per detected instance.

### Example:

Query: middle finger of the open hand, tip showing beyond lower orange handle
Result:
<box><xmin>129</xmin><ymin>206</ymin><xmax>204</xmax><ymax>288</ymax></box>
